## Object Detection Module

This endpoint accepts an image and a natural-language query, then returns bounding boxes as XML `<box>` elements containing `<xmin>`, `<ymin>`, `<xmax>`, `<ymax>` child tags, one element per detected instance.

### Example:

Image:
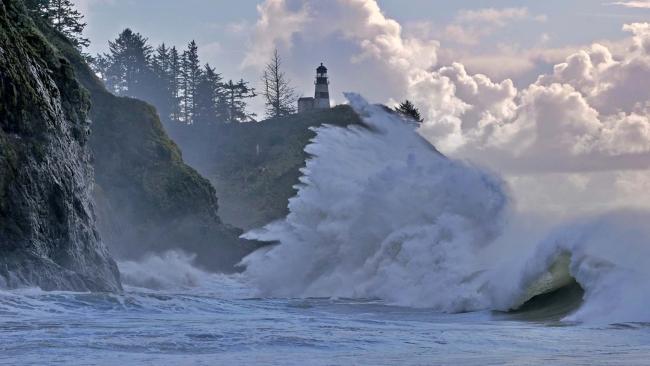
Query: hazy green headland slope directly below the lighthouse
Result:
<box><xmin>173</xmin><ymin>105</ymin><xmax>361</xmax><ymax>228</ymax></box>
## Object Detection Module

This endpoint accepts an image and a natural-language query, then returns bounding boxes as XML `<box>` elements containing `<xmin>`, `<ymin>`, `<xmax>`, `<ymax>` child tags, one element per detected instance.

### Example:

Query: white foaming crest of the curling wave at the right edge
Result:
<box><xmin>519</xmin><ymin>210</ymin><xmax>650</xmax><ymax>323</ymax></box>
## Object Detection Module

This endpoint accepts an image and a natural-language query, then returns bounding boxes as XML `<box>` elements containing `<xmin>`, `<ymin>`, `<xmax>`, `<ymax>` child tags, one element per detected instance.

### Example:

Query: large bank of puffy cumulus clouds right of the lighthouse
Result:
<box><xmin>409</xmin><ymin>23</ymin><xmax>650</xmax><ymax>171</ymax></box>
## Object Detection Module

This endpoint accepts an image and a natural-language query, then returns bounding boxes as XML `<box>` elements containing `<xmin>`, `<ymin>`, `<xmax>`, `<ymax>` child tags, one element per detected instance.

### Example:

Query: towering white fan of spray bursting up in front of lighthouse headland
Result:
<box><xmin>244</xmin><ymin>94</ymin><xmax>508</xmax><ymax>311</ymax></box>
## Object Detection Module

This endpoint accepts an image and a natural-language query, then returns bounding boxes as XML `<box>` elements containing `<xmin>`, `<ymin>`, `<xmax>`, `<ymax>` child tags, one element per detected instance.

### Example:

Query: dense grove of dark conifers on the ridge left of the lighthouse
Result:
<box><xmin>92</xmin><ymin>28</ymin><xmax>257</xmax><ymax>125</ymax></box>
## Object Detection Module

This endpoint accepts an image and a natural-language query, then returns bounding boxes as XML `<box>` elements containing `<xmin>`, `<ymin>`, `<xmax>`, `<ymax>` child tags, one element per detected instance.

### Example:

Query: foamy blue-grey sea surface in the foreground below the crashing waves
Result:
<box><xmin>0</xmin><ymin>271</ymin><xmax>650</xmax><ymax>365</ymax></box>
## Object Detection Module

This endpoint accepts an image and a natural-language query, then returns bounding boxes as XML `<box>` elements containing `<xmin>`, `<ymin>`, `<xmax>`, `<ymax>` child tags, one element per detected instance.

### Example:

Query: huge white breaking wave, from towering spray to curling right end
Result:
<box><xmin>243</xmin><ymin>94</ymin><xmax>650</xmax><ymax>322</ymax></box>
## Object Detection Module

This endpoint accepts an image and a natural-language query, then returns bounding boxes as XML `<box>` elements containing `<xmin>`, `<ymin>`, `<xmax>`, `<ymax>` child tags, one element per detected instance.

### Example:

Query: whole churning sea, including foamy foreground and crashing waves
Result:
<box><xmin>0</xmin><ymin>94</ymin><xmax>650</xmax><ymax>365</ymax></box>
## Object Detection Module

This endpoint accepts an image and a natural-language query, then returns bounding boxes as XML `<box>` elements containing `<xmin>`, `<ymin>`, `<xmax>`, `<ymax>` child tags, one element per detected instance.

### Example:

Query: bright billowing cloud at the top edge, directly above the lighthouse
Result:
<box><xmin>243</xmin><ymin>0</ymin><xmax>439</xmax><ymax>72</ymax></box>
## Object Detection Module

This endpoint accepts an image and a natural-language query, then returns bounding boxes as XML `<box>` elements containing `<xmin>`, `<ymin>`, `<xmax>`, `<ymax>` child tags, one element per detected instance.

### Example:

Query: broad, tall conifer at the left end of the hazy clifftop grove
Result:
<box><xmin>106</xmin><ymin>28</ymin><xmax>153</xmax><ymax>99</ymax></box>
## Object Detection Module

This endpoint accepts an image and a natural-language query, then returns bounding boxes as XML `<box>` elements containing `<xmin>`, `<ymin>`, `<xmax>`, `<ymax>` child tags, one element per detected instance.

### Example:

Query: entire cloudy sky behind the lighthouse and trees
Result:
<box><xmin>75</xmin><ymin>0</ymin><xmax>650</xmax><ymax>216</ymax></box>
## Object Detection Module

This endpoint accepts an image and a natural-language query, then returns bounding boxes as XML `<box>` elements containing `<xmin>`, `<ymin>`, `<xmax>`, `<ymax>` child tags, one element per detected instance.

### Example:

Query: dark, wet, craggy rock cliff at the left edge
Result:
<box><xmin>0</xmin><ymin>0</ymin><xmax>120</xmax><ymax>291</ymax></box>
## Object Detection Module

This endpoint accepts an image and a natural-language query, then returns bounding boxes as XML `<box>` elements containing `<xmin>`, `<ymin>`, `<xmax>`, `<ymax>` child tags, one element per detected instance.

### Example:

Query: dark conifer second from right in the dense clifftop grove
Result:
<box><xmin>194</xmin><ymin>64</ymin><xmax>223</xmax><ymax>126</ymax></box>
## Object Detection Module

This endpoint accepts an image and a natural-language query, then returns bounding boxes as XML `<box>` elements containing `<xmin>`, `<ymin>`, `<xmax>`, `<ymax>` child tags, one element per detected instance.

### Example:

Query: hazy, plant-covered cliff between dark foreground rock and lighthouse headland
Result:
<box><xmin>38</xmin><ymin>14</ymin><xmax>257</xmax><ymax>272</ymax></box>
